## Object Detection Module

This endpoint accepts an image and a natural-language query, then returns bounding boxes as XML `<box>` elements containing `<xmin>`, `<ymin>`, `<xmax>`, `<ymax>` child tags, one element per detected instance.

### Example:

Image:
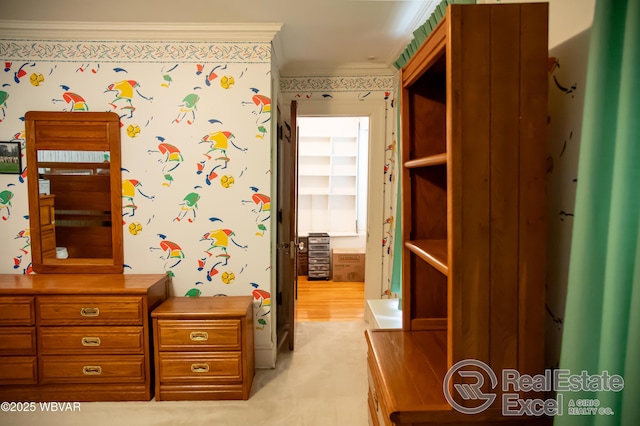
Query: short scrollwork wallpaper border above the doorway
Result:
<box><xmin>280</xmin><ymin>75</ymin><xmax>396</xmax><ymax>93</ymax></box>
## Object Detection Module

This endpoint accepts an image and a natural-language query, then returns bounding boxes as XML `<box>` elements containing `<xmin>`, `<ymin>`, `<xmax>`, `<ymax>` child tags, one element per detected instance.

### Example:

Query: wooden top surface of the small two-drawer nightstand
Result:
<box><xmin>151</xmin><ymin>296</ymin><xmax>253</xmax><ymax>319</ymax></box>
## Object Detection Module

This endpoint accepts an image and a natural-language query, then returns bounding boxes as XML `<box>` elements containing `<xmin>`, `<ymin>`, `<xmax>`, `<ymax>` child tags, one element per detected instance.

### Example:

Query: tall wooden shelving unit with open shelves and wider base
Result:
<box><xmin>367</xmin><ymin>3</ymin><xmax>548</xmax><ymax>424</ymax></box>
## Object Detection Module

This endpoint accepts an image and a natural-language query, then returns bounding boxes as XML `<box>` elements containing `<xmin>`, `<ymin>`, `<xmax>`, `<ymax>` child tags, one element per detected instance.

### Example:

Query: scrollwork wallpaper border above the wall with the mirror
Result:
<box><xmin>0</xmin><ymin>40</ymin><xmax>271</xmax><ymax>63</ymax></box>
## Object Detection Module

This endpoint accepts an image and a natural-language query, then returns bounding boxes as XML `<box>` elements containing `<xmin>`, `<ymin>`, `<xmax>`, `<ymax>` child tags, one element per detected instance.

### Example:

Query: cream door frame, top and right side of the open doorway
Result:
<box><xmin>298</xmin><ymin>99</ymin><xmax>386</xmax><ymax>304</ymax></box>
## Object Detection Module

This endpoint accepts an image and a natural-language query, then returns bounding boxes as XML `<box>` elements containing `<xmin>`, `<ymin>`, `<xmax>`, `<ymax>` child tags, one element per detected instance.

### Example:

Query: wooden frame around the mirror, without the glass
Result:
<box><xmin>25</xmin><ymin>111</ymin><xmax>124</xmax><ymax>274</ymax></box>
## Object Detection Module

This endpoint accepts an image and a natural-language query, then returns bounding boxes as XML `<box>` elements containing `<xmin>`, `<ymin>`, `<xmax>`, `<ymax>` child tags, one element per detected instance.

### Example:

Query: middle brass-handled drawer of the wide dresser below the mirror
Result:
<box><xmin>38</xmin><ymin>326</ymin><xmax>144</xmax><ymax>355</ymax></box>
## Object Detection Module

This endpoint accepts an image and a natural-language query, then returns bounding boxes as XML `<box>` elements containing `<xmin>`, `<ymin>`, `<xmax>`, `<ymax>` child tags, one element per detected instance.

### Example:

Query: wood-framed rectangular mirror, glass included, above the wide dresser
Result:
<box><xmin>25</xmin><ymin>111</ymin><xmax>124</xmax><ymax>273</ymax></box>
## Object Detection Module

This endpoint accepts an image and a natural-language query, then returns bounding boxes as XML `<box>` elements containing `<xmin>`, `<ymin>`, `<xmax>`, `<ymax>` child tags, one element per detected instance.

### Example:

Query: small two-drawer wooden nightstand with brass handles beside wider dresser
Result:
<box><xmin>151</xmin><ymin>296</ymin><xmax>255</xmax><ymax>401</ymax></box>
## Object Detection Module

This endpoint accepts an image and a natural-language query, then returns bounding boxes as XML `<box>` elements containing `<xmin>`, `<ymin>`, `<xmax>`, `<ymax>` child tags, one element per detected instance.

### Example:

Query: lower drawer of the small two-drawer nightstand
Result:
<box><xmin>158</xmin><ymin>352</ymin><xmax>242</xmax><ymax>383</ymax></box>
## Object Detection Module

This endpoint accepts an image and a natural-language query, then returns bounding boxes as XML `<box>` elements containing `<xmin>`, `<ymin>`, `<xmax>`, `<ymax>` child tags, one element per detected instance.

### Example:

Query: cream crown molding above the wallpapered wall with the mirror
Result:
<box><xmin>0</xmin><ymin>20</ymin><xmax>282</xmax><ymax>42</ymax></box>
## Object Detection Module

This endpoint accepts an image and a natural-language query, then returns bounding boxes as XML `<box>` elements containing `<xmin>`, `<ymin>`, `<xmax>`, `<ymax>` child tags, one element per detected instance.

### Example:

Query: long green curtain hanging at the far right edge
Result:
<box><xmin>555</xmin><ymin>0</ymin><xmax>640</xmax><ymax>426</ymax></box>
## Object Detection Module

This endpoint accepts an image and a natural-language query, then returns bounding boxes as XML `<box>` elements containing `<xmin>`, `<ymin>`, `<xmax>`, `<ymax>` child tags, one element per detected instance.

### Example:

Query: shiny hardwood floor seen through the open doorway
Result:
<box><xmin>296</xmin><ymin>276</ymin><xmax>364</xmax><ymax>322</ymax></box>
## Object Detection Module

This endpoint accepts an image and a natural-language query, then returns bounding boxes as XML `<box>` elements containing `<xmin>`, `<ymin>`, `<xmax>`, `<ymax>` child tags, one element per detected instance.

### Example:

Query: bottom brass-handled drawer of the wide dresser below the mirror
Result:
<box><xmin>40</xmin><ymin>355</ymin><xmax>145</xmax><ymax>384</ymax></box>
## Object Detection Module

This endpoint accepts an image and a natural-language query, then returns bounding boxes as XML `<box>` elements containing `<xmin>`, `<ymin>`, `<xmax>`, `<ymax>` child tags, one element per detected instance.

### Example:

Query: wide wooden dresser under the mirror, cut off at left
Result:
<box><xmin>0</xmin><ymin>274</ymin><xmax>170</xmax><ymax>401</ymax></box>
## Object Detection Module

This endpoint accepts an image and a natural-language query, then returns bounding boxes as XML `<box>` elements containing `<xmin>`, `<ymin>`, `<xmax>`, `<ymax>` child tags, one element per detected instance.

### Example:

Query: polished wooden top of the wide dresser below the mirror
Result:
<box><xmin>0</xmin><ymin>274</ymin><xmax>170</xmax><ymax>295</ymax></box>
